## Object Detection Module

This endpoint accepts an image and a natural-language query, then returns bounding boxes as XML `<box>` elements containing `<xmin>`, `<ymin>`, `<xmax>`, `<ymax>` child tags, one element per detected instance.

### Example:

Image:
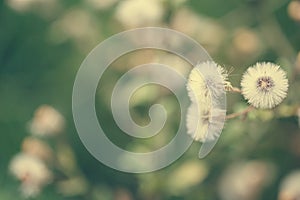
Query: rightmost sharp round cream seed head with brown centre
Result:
<box><xmin>241</xmin><ymin>62</ymin><xmax>288</xmax><ymax>109</ymax></box>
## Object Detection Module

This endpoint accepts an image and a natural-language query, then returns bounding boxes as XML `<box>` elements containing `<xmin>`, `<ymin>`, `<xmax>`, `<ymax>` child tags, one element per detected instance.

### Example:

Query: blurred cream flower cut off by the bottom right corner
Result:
<box><xmin>278</xmin><ymin>170</ymin><xmax>300</xmax><ymax>200</ymax></box>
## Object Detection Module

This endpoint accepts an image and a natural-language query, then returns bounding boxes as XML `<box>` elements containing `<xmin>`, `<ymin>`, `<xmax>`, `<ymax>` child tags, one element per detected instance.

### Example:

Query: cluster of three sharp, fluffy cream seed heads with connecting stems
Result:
<box><xmin>186</xmin><ymin>62</ymin><xmax>288</xmax><ymax>142</ymax></box>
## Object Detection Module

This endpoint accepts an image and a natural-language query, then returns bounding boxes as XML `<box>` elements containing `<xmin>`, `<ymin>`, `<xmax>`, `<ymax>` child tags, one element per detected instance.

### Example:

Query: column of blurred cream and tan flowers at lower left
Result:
<box><xmin>9</xmin><ymin>105</ymin><xmax>64</xmax><ymax>197</ymax></box>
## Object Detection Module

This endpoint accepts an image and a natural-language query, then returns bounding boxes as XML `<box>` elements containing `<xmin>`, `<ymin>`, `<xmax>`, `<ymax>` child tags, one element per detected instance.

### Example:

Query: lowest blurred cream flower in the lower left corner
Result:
<box><xmin>9</xmin><ymin>153</ymin><xmax>52</xmax><ymax>197</ymax></box>
